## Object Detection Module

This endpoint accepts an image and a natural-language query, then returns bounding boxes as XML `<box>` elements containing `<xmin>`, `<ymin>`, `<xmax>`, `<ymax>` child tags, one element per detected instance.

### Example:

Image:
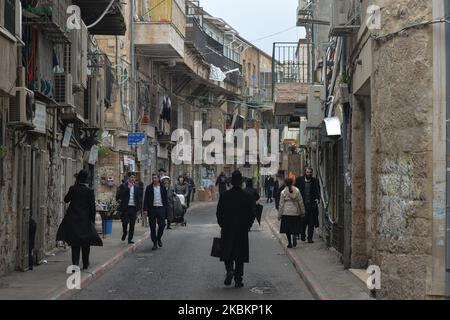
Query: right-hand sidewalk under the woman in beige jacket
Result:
<box><xmin>264</xmin><ymin>208</ymin><xmax>372</xmax><ymax>300</ymax></box>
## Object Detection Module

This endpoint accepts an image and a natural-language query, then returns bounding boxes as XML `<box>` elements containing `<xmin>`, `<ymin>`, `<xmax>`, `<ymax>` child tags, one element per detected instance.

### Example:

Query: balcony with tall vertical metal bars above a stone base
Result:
<box><xmin>272</xmin><ymin>43</ymin><xmax>311</xmax><ymax>124</ymax></box>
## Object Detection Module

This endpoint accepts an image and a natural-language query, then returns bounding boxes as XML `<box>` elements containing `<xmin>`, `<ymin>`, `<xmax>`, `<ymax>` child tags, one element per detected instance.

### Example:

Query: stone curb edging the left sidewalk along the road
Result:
<box><xmin>48</xmin><ymin>232</ymin><xmax>150</xmax><ymax>300</ymax></box>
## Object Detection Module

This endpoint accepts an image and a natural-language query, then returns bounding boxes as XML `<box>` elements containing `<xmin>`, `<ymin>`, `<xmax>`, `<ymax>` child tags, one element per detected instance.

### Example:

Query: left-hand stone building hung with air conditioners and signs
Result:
<box><xmin>0</xmin><ymin>0</ymin><xmax>123</xmax><ymax>274</ymax></box>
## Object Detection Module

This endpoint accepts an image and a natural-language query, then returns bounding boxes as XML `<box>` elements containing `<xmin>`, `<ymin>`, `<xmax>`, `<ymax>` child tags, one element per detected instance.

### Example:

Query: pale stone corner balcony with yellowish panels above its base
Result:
<box><xmin>135</xmin><ymin>0</ymin><xmax>186</xmax><ymax>60</ymax></box>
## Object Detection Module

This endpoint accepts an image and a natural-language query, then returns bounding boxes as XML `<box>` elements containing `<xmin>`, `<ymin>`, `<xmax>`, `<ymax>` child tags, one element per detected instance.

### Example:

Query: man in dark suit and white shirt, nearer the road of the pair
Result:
<box><xmin>144</xmin><ymin>174</ymin><xmax>169</xmax><ymax>250</ymax></box>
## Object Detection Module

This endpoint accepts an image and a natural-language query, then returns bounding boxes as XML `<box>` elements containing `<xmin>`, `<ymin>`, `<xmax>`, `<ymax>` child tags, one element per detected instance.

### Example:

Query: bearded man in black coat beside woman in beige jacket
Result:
<box><xmin>295</xmin><ymin>168</ymin><xmax>320</xmax><ymax>243</ymax></box>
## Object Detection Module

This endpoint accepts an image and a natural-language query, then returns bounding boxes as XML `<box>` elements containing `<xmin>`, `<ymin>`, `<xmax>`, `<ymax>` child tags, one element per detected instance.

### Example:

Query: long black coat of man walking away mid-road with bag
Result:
<box><xmin>217</xmin><ymin>187</ymin><xmax>256</xmax><ymax>263</ymax></box>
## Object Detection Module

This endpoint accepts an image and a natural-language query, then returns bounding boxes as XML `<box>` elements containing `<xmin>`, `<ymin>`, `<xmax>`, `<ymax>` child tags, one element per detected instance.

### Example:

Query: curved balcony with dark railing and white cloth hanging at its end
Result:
<box><xmin>186</xmin><ymin>18</ymin><xmax>242</xmax><ymax>87</ymax></box>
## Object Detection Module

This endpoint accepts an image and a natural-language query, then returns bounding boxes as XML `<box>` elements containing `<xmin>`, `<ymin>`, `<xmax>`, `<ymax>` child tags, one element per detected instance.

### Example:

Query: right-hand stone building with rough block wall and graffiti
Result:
<box><xmin>298</xmin><ymin>0</ymin><xmax>450</xmax><ymax>299</ymax></box>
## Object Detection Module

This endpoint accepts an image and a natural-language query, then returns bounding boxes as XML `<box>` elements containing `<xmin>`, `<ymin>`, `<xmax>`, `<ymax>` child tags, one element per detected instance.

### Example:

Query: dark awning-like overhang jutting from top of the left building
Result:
<box><xmin>73</xmin><ymin>0</ymin><xmax>127</xmax><ymax>36</ymax></box>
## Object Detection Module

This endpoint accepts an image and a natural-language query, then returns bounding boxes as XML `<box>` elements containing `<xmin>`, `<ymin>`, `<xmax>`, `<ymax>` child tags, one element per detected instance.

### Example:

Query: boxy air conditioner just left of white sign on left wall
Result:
<box><xmin>9</xmin><ymin>87</ymin><xmax>33</xmax><ymax>127</ymax></box>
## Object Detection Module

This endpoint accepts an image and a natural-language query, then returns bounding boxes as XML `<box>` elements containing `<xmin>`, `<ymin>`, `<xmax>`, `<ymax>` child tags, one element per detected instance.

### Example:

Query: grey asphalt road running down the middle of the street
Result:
<box><xmin>72</xmin><ymin>204</ymin><xmax>313</xmax><ymax>300</ymax></box>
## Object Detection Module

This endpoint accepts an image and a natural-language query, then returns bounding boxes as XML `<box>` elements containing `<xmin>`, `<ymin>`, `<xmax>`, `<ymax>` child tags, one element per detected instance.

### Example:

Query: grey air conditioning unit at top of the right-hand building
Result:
<box><xmin>330</xmin><ymin>0</ymin><xmax>359</xmax><ymax>37</ymax></box>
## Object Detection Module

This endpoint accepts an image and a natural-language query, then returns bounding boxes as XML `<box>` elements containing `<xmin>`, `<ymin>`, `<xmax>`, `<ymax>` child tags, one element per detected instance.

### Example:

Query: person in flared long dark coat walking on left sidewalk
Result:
<box><xmin>56</xmin><ymin>170</ymin><xmax>103</xmax><ymax>270</ymax></box>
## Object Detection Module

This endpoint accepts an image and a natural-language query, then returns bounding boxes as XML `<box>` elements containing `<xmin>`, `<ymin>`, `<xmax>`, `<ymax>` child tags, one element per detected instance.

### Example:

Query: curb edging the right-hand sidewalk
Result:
<box><xmin>264</xmin><ymin>210</ymin><xmax>333</xmax><ymax>300</ymax></box>
